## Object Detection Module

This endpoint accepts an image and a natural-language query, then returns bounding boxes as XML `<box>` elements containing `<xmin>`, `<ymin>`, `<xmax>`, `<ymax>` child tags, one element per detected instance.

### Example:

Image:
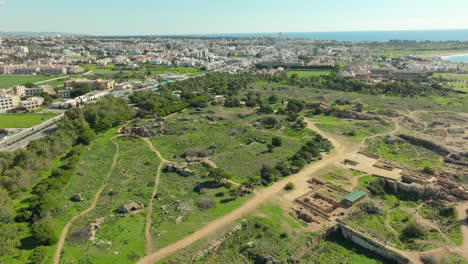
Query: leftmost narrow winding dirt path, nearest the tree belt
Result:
<box><xmin>53</xmin><ymin>136</ymin><xmax>120</xmax><ymax>264</ymax></box>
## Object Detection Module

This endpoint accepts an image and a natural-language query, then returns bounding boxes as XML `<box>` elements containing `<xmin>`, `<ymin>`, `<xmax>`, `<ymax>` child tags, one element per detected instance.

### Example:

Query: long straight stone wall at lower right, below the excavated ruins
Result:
<box><xmin>339</xmin><ymin>222</ymin><xmax>409</xmax><ymax>264</ymax></box>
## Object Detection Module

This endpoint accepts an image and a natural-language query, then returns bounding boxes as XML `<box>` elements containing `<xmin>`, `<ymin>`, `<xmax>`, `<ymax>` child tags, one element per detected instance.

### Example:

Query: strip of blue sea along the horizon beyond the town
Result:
<box><xmin>196</xmin><ymin>29</ymin><xmax>468</xmax><ymax>42</ymax></box>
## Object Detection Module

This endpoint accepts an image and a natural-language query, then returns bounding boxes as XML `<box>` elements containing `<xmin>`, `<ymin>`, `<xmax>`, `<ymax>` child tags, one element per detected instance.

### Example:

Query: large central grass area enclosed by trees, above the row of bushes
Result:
<box><xmin>152</xmin><ymin>107</ymin><xmax>315</xmax><ymax>182</ymax></box>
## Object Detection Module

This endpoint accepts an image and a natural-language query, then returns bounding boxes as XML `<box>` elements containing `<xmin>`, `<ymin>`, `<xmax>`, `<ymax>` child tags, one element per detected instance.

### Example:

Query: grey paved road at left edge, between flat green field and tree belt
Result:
<box><xmin>0</xmin><ymin>114</ymin><xmax>65</xmax><ymax>151</ymax></box>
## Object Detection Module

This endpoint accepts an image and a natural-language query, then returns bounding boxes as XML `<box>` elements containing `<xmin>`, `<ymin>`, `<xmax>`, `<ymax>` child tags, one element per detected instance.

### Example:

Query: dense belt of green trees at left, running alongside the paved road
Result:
<box><xmin>0</xmin><ymin>97</ymin><xmax>132</xmax><ymax>258</ymax></box>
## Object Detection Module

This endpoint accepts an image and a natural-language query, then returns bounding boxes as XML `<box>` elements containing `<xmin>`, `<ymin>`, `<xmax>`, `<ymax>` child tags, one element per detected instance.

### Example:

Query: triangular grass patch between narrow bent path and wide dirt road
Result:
<box><xmin>151</xmin><ymin>165</ymin><xmax>251</xmax><ymax>250</ymax></box>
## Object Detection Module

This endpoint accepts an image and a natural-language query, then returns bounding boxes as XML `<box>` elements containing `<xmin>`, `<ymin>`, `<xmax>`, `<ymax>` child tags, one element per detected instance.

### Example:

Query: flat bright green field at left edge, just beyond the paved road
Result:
<box><xmin>0</xmin><ymin>113</ymin><xmax>57</xmax><ymax>128</ymax></box>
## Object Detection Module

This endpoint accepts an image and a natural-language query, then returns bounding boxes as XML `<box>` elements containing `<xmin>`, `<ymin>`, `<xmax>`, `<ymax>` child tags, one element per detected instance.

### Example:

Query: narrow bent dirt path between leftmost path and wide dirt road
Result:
<box><xmin>141</xmin><ymin>138</ymin><xmax>168</xmax><ymax>254</ymax></box>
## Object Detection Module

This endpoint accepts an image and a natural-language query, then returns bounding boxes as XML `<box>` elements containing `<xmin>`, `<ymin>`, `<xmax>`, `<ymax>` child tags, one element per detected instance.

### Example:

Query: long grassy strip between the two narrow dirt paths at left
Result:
<box><xmin>63</xmin><ymin>138</ymin><xmax>160</xmax><ymax>263</ymax></box>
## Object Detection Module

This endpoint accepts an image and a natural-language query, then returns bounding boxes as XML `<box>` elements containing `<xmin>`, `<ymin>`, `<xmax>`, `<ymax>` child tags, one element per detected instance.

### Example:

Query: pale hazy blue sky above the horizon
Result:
<box><xmin>0</xmin><ymin>0</ymin><xmax>468</xmax><ymax>35</ymax></box>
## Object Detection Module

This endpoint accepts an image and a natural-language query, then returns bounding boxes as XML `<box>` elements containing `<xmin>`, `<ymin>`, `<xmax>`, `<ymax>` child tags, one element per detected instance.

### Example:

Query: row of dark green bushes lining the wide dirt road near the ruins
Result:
<box><xmin>256</xmin><ymin>135</ymin><xmax>332</xmax><ymax>186</ymax></box>
